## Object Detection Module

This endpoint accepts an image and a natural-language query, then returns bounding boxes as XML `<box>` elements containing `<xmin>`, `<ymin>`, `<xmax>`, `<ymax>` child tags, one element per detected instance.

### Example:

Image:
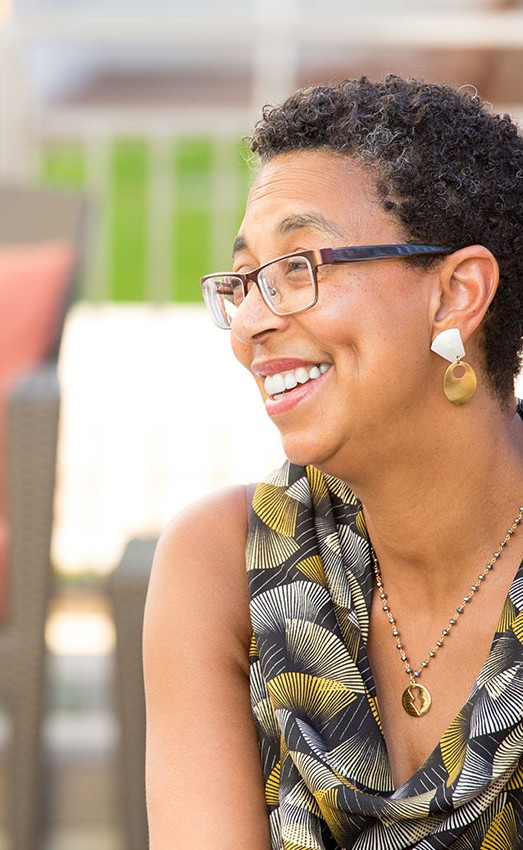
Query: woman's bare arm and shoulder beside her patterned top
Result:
<box><xmin>144</xmin><ymin>487</ymin><xmax>270</xmax><ymax>850</ymax></box>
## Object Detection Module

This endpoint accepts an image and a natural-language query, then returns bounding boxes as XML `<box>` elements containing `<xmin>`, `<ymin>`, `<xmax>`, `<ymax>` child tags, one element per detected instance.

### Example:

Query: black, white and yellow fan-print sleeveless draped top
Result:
<box><xmin>247</xmin><ymin>463</ymin><xmax>523</xmax><ymax>850</ymax></box>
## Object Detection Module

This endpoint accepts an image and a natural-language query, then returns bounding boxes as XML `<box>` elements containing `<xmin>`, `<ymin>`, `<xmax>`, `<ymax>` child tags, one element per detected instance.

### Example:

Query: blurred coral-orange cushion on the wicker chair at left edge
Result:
<box><xmin>0</xmin><ymin>242</ymin><xmax>73</xmax><ymax>615</ymax></box>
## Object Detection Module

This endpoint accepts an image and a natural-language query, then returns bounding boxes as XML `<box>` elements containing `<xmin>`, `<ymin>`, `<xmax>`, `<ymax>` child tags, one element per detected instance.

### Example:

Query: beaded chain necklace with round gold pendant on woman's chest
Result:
<box><xmin>370</xmin><ymin>506</ymin><xmax>523</xmax><ymax>717</ymax></box>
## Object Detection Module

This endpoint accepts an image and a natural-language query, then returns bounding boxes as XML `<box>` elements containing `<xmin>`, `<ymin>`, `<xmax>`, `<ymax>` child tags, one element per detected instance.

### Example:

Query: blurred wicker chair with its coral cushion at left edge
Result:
<box><xmin>0</xmin><ymin>184</ymin><xmax>85</xmax><ymax>850</ymax></box>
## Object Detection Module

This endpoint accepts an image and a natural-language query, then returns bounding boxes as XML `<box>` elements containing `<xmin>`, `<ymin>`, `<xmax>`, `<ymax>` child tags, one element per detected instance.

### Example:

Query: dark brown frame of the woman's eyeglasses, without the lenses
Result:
<box><xmin>200</xmin><ymin>242</ymin><xmax>455</xmax><ymax>330</ymax></box>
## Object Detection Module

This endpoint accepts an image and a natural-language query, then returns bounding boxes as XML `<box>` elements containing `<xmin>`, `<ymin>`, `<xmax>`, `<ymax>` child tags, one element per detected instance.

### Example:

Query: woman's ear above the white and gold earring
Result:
<box><xmin>433</xmin><ymin>245</ymin><xmax>499</xmax><ymax>340</ymax></box>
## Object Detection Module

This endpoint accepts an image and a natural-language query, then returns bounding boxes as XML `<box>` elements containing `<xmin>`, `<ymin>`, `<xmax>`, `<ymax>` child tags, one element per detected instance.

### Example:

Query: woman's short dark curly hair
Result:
<box><xmin>250</xmin><ymin>75</ymin><xmax>523</xmax><ymax>402</ymax></box>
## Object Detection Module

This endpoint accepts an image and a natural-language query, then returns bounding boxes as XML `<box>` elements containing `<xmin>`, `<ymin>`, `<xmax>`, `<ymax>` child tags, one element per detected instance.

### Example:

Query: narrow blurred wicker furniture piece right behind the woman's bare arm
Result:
<box><xmin>110</xmin><ymin>537</ymin><xmax>157</xmax><ymax>850</ymax></box>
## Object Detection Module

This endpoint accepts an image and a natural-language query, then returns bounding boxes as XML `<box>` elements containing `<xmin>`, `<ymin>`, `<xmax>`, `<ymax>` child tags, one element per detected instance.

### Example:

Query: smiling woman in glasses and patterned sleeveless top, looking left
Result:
<box><xmin>145</xmin><ymin>77</ymin><xmax>523</xmax><ymax>850</ymax></box>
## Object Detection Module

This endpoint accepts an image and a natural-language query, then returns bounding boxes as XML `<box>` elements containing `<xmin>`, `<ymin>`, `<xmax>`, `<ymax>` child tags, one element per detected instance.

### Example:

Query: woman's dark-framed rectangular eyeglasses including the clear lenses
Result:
<box><xmin>201</xmin><ymin>244</ymin><xmax>453</xmax><ymax>330</ymax></box>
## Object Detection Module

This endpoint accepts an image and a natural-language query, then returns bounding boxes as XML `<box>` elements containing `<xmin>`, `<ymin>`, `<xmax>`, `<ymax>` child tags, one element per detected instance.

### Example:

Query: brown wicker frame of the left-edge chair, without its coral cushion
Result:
<box><xmin>0</xmin><ymin>184</ymin><xmax>85</xmax><ymax>850</ymax></box>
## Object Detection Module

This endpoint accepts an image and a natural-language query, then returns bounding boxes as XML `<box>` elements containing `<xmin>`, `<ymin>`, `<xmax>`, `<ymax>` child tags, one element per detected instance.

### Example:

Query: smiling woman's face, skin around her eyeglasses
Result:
<box><xmin>232</xmin><ymin>151</ymin><xmax>436</xmax><ymax>480</ymax></box>
